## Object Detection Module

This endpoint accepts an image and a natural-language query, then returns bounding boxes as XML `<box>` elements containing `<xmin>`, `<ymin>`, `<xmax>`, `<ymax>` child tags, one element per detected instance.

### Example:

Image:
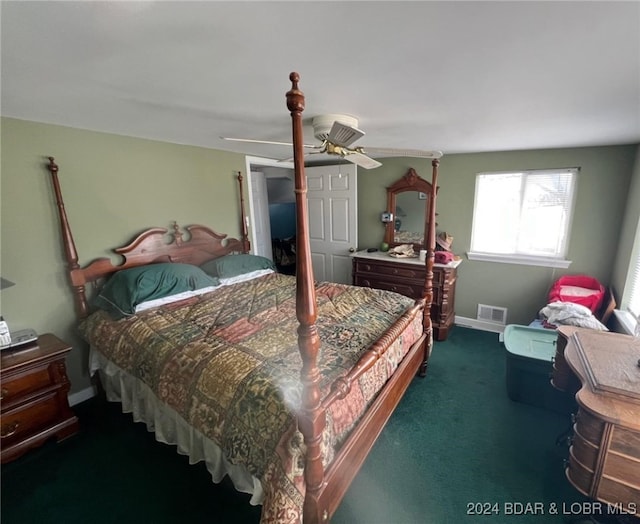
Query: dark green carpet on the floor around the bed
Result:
<box><xmin>1</xmin><ymin>327</ymin><xmax>584</xmax><ymax>524</ymax></box>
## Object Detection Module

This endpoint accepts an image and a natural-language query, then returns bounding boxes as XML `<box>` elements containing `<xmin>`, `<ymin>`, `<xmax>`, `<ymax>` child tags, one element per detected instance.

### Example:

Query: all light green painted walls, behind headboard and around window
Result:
<box><xmin>0</xmin><ymin>118</ymin><xmax>640</xmax><ymax>398</ymax></box>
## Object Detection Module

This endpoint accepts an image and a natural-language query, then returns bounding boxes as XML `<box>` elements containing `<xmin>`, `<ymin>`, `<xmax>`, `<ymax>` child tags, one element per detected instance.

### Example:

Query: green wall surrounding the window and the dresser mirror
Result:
<box><xmin>358</xmin><ymin>145</ymin><xmax>640</xmax><ymax>324</ymax></box>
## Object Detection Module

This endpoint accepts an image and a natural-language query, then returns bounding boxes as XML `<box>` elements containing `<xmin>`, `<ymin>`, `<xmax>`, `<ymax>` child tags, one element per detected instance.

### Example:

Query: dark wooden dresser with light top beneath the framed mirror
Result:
<box><xmin>351</xmin><ymin>251</ymin><xmax>461</xmax><ymax>341</ymax></box>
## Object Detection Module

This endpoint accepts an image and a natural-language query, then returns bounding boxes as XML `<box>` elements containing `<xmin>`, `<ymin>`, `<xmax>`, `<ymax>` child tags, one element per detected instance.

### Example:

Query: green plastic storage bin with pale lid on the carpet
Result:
<box><xmin>504</xmin><ymin>324</ymin><xmax>576</xmax><ymax>414</ymax></box>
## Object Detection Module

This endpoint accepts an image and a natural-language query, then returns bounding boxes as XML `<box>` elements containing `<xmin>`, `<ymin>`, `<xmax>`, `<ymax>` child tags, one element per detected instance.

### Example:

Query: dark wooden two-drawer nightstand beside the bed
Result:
<box><xmin>0</xmin><ymin>333</ymin><xmax>79</xmax><ymax>464</ymax></box>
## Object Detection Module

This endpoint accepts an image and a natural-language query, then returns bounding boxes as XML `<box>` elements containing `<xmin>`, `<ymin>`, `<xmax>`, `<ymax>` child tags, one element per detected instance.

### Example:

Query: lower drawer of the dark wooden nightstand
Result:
<box><xmin>0</xmin><ymin>391</ymin><xmax>61</xmax><ymax>448</ymax></box>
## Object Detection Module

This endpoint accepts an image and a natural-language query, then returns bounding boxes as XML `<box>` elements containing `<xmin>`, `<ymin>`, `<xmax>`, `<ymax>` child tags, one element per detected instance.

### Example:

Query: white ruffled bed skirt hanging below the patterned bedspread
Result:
<box><xmin>89</xmin><ymin>348</ymin><xmax>264</xmax><ymax>506</ymax></box>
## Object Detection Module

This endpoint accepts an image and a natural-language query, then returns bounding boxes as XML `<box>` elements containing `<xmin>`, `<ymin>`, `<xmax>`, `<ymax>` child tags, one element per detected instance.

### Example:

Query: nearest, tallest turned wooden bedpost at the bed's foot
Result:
<box><xmin>287</xmin><ymin>72</ymin><xmax>328</xmax><ymax>524</ymax></box>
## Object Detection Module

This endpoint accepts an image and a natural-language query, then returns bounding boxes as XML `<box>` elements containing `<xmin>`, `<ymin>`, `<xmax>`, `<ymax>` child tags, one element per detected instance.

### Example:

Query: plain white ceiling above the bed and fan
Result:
<box><xmin>0</xmin><ymin>1</ymin><xmax>640</xmax><ymax>162</ymax></box>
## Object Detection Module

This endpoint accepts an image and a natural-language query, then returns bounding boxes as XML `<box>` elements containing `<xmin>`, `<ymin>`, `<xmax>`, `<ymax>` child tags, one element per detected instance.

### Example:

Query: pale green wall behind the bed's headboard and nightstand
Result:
<box><xmin>0</xmin><ymin>118</ymin><xmax>246</xmax><ymax>398</ymax></box>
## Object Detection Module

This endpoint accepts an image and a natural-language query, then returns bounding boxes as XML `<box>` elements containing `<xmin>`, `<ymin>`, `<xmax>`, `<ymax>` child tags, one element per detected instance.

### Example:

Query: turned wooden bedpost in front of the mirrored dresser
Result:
<box><xmin>419</xmin><ymin>158</ymin><xmax>440</xmax><ymax>377</ymax></box>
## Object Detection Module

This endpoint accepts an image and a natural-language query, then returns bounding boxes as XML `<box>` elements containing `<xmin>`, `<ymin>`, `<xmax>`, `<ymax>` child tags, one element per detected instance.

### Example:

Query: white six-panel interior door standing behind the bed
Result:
<box><xmin>305</xmin><ymin>164</ymin><xmax>358</xmax><ymax>284</ymax></box>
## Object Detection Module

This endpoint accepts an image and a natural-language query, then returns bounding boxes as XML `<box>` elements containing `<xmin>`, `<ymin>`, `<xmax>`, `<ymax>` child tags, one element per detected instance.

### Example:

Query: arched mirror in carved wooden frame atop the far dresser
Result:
<box><xmin>384</xmin><ymin>168</ymin><xmax>433</xmax><ymax>251</ymax></box>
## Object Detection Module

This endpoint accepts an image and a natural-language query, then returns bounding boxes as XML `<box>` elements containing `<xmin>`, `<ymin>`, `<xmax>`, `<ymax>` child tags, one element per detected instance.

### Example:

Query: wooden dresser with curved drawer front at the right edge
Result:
<box><xmin>564</xmin><ymin>329</ymin><xmax>640</xmax><ymax>517</ymax></box>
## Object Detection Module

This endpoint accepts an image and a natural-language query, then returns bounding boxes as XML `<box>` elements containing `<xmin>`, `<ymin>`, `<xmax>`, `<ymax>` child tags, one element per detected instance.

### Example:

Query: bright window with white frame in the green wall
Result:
<box><xmin>468</xmin><ymin>168</ymin><xmax>578</xmax><ymax>267</ymax></box>
